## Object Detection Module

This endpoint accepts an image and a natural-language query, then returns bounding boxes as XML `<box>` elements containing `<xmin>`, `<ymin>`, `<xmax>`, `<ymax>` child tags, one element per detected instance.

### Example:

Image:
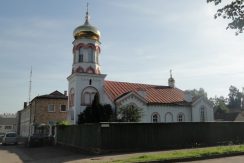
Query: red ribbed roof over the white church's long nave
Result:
<box><xmin>104</xmin><ymin>81</ymin><xmax>185</xmax><ymax>104</ymax></box>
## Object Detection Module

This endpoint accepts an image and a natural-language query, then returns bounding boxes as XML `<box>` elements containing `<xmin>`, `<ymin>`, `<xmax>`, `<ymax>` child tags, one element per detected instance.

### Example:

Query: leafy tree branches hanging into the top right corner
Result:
<box><xmin>207</xmin><ymin>0</ymin><xmax>244</xmax><ymax>35</ymax></box>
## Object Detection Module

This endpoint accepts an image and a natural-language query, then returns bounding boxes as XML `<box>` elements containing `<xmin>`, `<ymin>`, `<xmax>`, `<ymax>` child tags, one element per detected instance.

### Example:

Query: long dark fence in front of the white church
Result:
<box><xmin>57</xmin><ymin>122</ymin><xmax>244</xmax><ymax>152</ymax></box>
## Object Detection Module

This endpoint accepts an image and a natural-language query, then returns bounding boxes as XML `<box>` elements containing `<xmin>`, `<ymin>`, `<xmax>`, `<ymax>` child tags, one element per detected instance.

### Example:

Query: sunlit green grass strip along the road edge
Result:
<box><xmin>112</xmin><ymin>145</ymin><xmax>244</xmax><ymax>163</ymax></box>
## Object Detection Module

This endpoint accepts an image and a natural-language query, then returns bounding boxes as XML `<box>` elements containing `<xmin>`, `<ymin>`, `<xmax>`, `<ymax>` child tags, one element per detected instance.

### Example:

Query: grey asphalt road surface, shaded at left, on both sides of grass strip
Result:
<box><xmin>0</xmin><ymin>144</ymin><xmax>244</xmax><ymax>163</ymax></box>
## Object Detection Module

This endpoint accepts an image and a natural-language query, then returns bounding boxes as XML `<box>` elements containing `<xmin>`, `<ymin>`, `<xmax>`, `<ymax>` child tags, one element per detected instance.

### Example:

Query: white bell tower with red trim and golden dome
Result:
<box><xmin>67</xmin><ymin>4</ymin><xmax>106</xmax><ymax>124</ymax></box>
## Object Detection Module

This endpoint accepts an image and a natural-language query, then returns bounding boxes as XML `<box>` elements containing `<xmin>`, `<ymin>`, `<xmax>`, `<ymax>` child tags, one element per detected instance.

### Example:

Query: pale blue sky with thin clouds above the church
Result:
<box><xmin>0</xmin><ymin>0</ymin><xmax>244</xmax><ymax>113</ymax></box>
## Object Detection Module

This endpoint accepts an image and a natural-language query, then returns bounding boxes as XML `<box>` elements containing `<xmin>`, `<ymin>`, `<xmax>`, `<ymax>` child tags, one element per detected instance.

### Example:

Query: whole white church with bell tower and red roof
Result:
<box><xmin>67</xmin><ymin>10</ymin><xmax>214</xmax><ymax>124</ymax></box>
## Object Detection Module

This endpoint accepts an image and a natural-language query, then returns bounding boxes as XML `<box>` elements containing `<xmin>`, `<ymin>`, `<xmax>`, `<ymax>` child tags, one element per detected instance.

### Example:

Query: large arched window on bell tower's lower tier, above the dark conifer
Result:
<box><xmin>81</xmin><ymin>86</ymin><xmax>98</xmax><ymax>105</ymax></box>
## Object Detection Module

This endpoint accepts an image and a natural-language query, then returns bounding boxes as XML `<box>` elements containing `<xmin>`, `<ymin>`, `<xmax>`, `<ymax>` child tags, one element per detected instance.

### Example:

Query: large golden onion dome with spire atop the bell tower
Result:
<box><xmin>73</xmin><ymin>12</ymin><xmax>101</xmax><ymax>41</ymax></box>
